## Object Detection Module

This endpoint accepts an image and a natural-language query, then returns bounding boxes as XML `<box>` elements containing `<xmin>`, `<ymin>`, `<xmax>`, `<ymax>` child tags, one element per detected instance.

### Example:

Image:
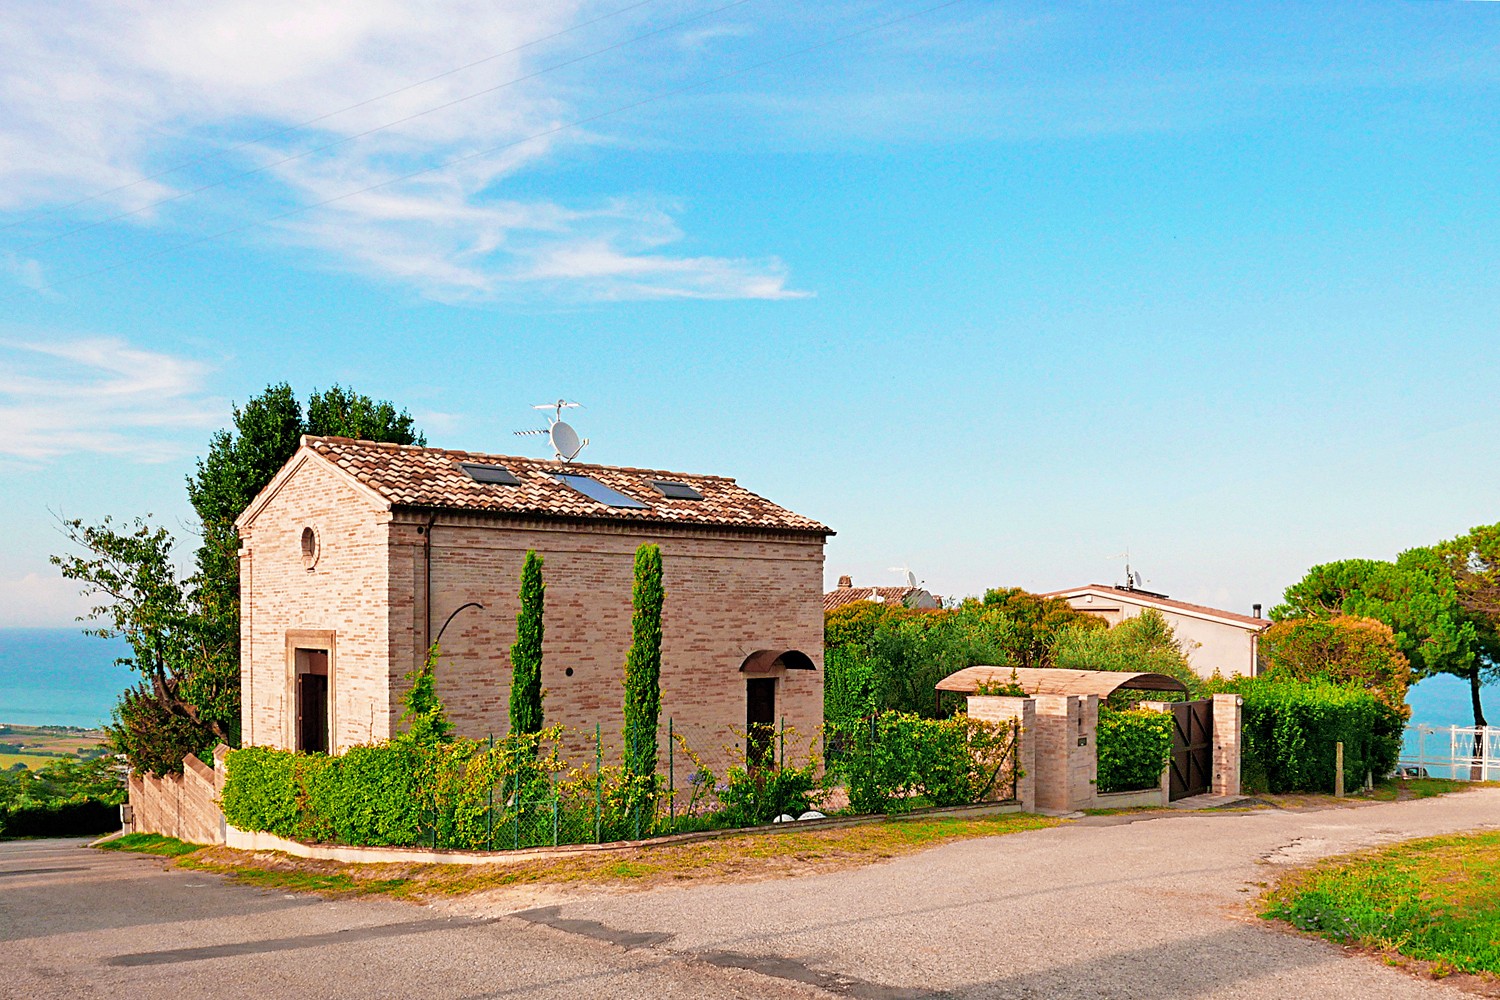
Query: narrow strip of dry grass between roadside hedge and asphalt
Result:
<box><xmin>179</xmin><ymin>813</ymin><xmax>1061</xmax><ymax>898</ymax></box>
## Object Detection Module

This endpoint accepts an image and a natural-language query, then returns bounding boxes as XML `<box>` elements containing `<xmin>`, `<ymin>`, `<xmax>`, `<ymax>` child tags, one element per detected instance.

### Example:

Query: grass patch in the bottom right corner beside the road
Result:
<box><xmin>1262</xmin><ymin>832</ymin><xmax>1500</xmax><ymax>976</ymax></box>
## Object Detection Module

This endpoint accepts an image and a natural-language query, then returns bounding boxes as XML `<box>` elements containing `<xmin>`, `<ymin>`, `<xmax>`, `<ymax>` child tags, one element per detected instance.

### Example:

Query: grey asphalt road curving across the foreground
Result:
<box><xmin>0</xmin><ymin>789</ymin><xmax>1500</xmax><ymax>1000</ymax></box>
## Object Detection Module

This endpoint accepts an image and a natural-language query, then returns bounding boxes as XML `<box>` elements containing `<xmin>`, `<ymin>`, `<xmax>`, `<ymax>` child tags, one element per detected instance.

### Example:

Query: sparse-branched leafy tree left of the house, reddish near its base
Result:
<box><xmin>53</xmin><ymin>517</ymin><xmax>240</xmax><ymax>774</ymax></box>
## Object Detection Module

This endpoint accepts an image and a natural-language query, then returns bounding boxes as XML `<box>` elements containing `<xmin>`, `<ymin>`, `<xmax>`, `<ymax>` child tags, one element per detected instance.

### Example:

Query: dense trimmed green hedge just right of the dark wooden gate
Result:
<box><xmin>1224</xmin><ymin>678</ymin><xmax>1406</xmax><ymax>793</ymax></box>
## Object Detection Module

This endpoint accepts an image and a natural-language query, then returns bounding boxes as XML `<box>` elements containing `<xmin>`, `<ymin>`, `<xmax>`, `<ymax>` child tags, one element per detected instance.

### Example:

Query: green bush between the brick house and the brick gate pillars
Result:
<box><xmin>840</xmin><ymin>712</ymin><xmax>1016</xmax><ymax>813</ymax></box>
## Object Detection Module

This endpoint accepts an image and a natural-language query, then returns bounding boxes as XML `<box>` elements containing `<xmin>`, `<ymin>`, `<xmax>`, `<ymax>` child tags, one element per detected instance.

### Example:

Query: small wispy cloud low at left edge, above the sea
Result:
<box><xmin>0</xmin><ymin>339</ymin><xmax>225</xmax><ymax>462</ymax></box>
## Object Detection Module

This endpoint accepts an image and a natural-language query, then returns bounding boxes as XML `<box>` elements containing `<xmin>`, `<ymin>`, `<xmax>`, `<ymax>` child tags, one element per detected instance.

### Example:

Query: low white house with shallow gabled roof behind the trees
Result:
<box><xmin>1043</xmin><ymin>583</ymin><xmax>1271</xmax><ymax>678</ymax></box>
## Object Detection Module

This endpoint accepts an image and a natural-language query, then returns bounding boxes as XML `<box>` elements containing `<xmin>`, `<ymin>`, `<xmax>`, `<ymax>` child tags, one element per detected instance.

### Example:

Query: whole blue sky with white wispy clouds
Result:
<box><xmin>0</xmin><ymin>0</ymin><xmax>1500</xmax><ymax>625</ymax></box>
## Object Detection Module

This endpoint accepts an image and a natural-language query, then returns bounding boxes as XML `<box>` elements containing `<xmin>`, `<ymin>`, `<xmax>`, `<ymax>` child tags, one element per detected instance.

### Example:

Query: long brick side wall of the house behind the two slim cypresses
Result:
<box><xmin>389</xmin><ymin>516</ymin><xmax>824</xmax><ymax>781</ymax></box>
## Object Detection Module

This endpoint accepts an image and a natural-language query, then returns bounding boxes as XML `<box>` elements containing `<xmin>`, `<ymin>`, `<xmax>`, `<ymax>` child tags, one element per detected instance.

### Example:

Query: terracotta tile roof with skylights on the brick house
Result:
<box><xmin>303</xmin><ymin>435</ymin><xmax>834</xmax><ymax>535</ymax></box>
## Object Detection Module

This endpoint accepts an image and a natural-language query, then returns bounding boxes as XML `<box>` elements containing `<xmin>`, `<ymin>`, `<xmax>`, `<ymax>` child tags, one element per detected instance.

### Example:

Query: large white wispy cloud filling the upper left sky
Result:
<box><xmin>0</xmin><ymin>0</ymin><xmax>795</xmax><ymax>300</ymax></box>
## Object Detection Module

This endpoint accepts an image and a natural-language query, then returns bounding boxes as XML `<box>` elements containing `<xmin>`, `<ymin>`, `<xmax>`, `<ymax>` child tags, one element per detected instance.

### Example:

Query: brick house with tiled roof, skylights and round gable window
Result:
<box><xmin>236</xmin><ymin>436</ymin><xmax>833</xmax><ymax>763</ymax></box>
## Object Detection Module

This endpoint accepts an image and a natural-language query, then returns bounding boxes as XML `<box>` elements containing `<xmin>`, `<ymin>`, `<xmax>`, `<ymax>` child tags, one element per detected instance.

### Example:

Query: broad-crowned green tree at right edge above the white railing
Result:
<box><xmin>1271</xmin><ymin>551</ymin><xmax>1500</xmax><ymax>726</ymax></box>
